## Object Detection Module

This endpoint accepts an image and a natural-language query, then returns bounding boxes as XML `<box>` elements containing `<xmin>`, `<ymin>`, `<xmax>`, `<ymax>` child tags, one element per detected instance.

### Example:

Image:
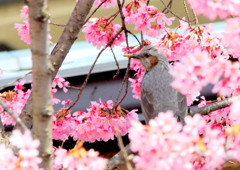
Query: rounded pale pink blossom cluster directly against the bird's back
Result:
<box><xmin>170</xmin><ymin>48</ymin><xmax>210</xmax><ymax>103</ymax></box>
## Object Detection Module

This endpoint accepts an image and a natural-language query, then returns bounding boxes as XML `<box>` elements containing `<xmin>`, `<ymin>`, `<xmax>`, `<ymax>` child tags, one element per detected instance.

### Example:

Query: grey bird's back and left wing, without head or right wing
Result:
<box><xmin>141</xmin><ymin>70</ymin><xmax>178</xmax><ymax>123</ymax></box>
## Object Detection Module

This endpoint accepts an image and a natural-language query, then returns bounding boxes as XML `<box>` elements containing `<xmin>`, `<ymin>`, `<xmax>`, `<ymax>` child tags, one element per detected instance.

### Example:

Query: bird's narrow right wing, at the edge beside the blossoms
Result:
<box><xmin>177</xmin><ymin>92</ymin><xmax>188</xmax><ymax>124</ymax></box>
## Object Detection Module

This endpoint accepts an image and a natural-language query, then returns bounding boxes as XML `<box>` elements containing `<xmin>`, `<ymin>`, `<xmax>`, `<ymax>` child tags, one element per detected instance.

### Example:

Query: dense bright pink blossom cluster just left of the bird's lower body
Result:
<box><xmin>70</xmin><ymin>100</ymin><xmax>138</xmax><ymax>142</ymax></box>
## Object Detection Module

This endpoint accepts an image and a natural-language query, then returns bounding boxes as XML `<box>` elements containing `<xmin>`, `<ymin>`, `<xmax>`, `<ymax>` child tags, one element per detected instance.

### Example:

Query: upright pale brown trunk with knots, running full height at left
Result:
<box><xmin>28</xmin><ymin>0</ymin><xmax>53</xmax><ymax>170</ymax></box>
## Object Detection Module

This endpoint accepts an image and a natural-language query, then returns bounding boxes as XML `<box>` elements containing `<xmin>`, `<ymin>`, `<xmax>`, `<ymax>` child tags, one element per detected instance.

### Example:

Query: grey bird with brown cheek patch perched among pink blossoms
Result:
<box><xmin>124</xmin><ymin>45</ymin><xmax>188</xmax><ymax>125</ymax></box>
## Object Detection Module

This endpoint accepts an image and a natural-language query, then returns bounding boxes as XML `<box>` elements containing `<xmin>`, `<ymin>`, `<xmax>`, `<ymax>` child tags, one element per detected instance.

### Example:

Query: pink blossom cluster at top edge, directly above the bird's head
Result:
<box><xmin>123</xmin><ymin>1</ymin><xmax>174</xmax><ymax>37</ymax></box>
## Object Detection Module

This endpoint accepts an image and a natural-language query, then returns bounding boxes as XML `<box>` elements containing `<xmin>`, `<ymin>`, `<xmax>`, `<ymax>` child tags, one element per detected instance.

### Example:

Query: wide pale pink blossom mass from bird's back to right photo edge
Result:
<box><xmin>170</xmin><ymin>48</ymin><xmax>240</xmax><ymax>100</ymax></box>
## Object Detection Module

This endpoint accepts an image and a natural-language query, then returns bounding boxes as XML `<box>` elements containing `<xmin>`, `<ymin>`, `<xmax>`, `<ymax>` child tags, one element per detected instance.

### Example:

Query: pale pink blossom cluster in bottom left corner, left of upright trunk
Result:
<box><xmin>0</xmin><ymin>130</ymin><xmax>42</xmax><ymax>170</ymax></box>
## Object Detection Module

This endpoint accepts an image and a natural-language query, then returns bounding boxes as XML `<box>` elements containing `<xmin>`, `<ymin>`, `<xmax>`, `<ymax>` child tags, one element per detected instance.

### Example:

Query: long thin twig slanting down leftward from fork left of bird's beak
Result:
<box><xmin>66</xmin><ymin>29</ymin><xmax>123</xmax><ymax>112</ymax></box>
